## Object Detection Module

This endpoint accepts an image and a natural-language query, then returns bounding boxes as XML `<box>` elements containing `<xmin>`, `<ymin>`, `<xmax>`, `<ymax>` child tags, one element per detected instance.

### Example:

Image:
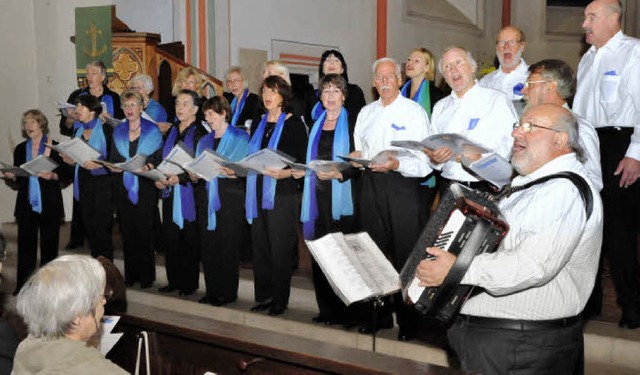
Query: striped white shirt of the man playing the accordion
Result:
<box><xmin>461</xmin><ymin>153</ymin><xmax>602</xmax><ymax>320</ymax></box>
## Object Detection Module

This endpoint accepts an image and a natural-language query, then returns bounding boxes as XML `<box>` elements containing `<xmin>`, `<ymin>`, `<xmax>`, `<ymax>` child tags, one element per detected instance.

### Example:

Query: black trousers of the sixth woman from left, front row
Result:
<box><xmin>251</xmin><ymin>189</ymin><xmax>300</xmax><ymax>307</ymax></box>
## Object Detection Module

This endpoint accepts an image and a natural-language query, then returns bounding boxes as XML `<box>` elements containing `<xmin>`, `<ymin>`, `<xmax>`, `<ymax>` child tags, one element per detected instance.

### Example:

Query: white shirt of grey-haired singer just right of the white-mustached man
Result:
<box><xmin>431</xmin><ymin>84</ymin><xmax>518</xmax><ymax>181</ymax></box>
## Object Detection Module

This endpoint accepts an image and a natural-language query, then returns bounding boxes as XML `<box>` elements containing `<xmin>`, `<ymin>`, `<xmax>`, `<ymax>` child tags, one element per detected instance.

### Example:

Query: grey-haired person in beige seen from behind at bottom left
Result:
<box><xmin>13</xmin><ymin>255</ymin><xmax>127</xmax><ymax>374</ymax></box>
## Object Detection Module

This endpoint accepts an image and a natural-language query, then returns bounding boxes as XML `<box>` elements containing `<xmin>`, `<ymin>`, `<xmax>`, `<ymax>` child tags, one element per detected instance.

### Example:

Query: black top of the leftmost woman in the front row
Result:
<box><xmin>7</xmin><ymin>141</ymin><xmax>73</xmax><ymax>218</ymax></box>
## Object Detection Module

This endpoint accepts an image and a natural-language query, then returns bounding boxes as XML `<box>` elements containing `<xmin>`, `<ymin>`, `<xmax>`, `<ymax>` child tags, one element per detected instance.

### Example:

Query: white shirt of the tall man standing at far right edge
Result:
<box><xmin>573</xmin><ymin>31</ymin><xmax>640</xmax><ymax>160</ymax></box>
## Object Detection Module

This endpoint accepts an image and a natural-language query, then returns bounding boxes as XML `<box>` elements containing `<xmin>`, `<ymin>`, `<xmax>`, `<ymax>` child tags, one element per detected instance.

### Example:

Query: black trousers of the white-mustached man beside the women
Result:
<box><xmin>358</xmin><ymin>170</ymin><xmax>429</xmax><ymax>330</ymax></box>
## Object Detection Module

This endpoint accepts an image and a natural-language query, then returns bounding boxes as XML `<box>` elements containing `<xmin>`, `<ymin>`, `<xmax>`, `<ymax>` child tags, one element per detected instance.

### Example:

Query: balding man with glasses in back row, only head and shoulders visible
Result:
<box><xmin>478</xmin><ymin>25</ymin><xmax>528</xmax><ymax>101</ymax></box>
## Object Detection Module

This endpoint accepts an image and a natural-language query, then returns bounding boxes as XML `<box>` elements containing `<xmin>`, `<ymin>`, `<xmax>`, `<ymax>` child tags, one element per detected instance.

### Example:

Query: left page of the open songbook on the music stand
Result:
<box><xmin>305</xmin><ymin>232</ymin><xmax>375</xmax><ymax>305</ymax></box>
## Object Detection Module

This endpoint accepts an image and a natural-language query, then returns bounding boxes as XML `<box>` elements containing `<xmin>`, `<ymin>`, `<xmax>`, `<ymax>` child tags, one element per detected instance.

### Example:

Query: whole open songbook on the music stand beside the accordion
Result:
<box><xmin>305</xmin><ymin>232</ymin><xmax>400</xmax><ymax>305</ymax></box>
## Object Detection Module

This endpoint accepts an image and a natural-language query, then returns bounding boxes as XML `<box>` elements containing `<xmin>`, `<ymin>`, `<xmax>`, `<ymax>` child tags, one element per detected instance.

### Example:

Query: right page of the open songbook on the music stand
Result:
<box><xmin>345</xmin><ymin>232</ymin><xmax>401</xmax><ymax>295</ymax></box>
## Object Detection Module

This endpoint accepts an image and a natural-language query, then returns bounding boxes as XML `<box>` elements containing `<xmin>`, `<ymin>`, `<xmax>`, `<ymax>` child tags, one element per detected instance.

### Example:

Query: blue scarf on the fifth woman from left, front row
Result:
<box><xmin>196</xmin><ymin>126</ymin><xmax>249</xmax><ymax>230</ymax></box>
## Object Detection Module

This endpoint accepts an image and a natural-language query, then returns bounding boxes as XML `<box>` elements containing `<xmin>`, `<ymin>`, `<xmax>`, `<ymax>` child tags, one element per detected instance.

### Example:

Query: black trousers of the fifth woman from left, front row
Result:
<box><xmin>198</xmin><ymin>181</ymin><xmax>246</xmax><ymax>302</ymax></box>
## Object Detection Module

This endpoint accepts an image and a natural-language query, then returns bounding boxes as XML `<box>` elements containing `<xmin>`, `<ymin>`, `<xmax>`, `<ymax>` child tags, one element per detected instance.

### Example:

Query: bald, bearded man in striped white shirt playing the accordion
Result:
<box><xmin>417</xmin><ymin>104</ymin><xmax>603</xmax><ymax>374</ymax></box>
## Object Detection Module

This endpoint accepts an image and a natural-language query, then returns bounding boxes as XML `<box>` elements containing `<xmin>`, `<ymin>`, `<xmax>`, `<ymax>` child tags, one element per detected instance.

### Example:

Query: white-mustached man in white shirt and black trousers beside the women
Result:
<box><xmin>351</xmin><ymin>58</ymin><xmax>431</xmax><ymax>340</ymax></box>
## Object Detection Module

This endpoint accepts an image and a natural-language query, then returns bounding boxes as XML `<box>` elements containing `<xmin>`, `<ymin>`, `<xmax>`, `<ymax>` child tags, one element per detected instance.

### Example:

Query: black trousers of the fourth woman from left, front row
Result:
<box><xmin>161</xmin><ymin>193</ymin><xmax>200</xmax><ymax>292</ymax></box>
